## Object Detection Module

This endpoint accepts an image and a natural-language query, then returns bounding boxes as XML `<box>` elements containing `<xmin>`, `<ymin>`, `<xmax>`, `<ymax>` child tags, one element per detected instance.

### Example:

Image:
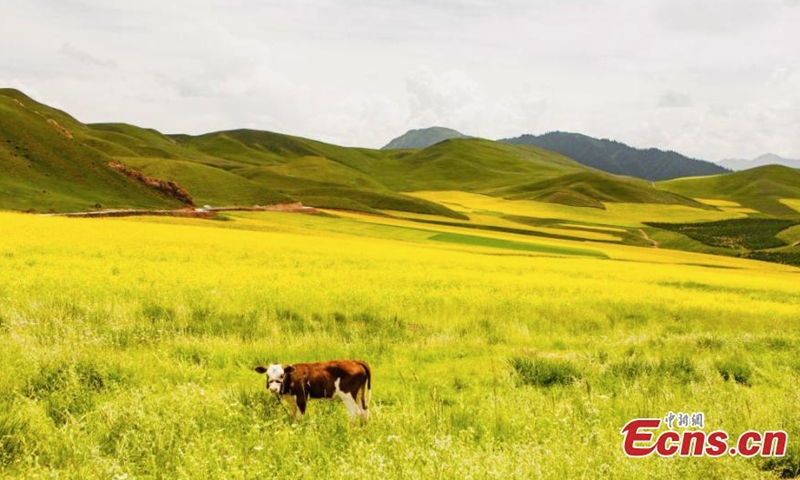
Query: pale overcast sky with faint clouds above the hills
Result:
<box><xmin>0</xmin><ymin>0</ymin><xmax>800</xmax><ymax>160</ymax></box>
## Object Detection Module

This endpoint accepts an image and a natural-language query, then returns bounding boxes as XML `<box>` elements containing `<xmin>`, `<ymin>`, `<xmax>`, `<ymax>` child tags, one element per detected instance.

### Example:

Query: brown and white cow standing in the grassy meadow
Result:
<box><xmin>255</xmin><ymin>360</ymin><xmax>372</xmax><ymax>421</ymax></box>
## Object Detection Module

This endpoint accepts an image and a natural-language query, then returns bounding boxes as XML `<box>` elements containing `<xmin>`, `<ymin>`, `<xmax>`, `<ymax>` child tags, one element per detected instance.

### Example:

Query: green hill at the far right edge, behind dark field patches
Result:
<box><xmin>658</xmin><ymin>165</ymin><xmax>800</xmax><ymax>217</ymax></box>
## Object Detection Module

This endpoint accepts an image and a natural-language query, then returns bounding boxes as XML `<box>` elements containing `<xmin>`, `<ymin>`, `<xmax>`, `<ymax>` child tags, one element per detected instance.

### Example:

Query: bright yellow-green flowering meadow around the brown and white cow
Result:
<box><xmin>0</xmin><ymin>208</ymin><xmax>800</xmax><ymax>479</ymax></box>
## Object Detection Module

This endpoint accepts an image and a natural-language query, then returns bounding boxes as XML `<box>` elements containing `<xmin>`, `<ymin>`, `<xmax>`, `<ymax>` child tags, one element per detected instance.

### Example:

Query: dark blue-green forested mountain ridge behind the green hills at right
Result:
<box><xmin>501</xmin><ymin>132</ymin><xmax>727</xmax><ymax>181</ymax></box>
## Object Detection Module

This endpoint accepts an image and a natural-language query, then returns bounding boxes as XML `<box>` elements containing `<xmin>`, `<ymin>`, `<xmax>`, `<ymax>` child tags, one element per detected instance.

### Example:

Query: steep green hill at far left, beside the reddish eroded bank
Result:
<box><xmin>0</xmin><ymin>89</ymin><xmax>184</xmax><ymax>212</ymax></box>
